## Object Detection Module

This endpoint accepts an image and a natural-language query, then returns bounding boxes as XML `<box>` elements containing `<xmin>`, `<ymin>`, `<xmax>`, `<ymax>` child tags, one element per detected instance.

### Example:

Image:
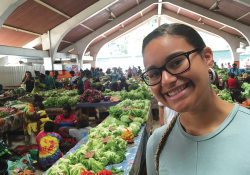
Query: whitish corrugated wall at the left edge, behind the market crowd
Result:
<box><xmin>0</xmin><ymin>65</ymin><xmax>45</xmax><ymax>86</ymax></box>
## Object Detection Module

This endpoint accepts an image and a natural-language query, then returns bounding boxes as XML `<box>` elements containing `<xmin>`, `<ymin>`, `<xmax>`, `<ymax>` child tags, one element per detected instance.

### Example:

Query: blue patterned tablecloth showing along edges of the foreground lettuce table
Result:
<box><xmin>43</xmin><ymin>125</ymin><xmax>148</xmax><ymax>175</ymax></box>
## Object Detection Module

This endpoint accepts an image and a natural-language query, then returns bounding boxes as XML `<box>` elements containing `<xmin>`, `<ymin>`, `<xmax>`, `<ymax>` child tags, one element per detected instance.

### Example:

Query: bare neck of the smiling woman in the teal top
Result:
<box><xmin>180</xmin><ymin>87</ymin><xmax>234</xmax><ymax>136</ymax></box>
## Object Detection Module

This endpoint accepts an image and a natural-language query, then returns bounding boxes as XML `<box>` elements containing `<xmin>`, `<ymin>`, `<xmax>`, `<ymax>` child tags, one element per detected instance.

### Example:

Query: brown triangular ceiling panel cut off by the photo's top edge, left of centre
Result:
<box><xmin>42</xmin><ymin>0</ymin><xmax>99</xmax><ymax>17</ymax></box>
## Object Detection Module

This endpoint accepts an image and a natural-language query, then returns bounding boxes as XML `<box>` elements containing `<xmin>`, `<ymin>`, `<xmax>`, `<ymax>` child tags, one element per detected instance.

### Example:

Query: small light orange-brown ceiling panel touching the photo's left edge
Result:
<box><xmin>0</xmin><ymin>27</ymin><xmax>37</xmax><ymax>47</ymax></box>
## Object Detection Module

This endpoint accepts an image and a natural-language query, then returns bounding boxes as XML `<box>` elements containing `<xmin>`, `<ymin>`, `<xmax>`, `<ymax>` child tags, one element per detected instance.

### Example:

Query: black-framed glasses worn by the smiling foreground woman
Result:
<box><xmin>141</xmin><ymin>47</ymin><xmax>204</xmax><ymax>86</ymax></box>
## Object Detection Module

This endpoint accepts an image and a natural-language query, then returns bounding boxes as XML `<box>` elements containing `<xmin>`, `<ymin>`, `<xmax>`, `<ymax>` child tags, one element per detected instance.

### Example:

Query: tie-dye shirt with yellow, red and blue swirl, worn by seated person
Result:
<box><xmin>36</xmin><ymin>131</ymin><xmax>63</xmax><ymax>166</ymax></box>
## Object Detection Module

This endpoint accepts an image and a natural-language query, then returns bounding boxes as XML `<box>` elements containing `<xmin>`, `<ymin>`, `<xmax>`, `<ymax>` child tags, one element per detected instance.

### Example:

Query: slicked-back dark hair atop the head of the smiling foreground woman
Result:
<box><xmin>142</xmin><ymin>23</ymin><xmax>206</xmax><ymax>52</ymax></box>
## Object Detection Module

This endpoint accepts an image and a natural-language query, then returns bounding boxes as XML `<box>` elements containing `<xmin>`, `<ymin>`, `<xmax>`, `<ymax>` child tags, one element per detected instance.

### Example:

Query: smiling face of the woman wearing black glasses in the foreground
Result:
<box><xmin>143</xmin><ymin>35</ymin><xmax>213</xmax><ymax>113</ymax></box>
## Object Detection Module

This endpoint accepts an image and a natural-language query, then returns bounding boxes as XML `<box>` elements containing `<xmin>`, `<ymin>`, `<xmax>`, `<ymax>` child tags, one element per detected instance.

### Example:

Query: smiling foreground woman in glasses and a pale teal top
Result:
<box><xmin>141</xmin><ymin>23</ymin><xmax>250</xmax><ymax>175</ymax></box>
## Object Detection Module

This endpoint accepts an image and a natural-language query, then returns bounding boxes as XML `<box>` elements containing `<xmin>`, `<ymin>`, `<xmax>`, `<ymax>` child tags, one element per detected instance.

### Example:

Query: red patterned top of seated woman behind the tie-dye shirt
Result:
<box><xmin>54</xmin><ymin>114</ymin><xmax>77</xmax><ymax>129</ymax></box>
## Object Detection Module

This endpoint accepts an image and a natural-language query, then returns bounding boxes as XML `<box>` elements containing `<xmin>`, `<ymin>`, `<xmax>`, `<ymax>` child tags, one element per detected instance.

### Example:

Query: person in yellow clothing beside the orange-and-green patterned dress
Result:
<box><xmin>27</xmin><ymin>104</ymin><xmax>52</xmax><ymax>139</ymax></box>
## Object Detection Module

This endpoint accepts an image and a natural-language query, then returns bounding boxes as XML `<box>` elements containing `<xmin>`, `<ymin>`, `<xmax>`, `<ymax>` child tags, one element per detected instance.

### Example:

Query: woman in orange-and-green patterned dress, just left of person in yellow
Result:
<box><xmin>23</xmin><ymin>95</ymin><xmax>43</xmax><ymax>145</ymax></box>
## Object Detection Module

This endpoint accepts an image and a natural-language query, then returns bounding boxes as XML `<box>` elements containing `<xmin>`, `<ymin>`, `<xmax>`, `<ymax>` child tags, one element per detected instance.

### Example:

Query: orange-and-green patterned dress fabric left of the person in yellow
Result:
<box><xmin>23</xmin><ymin>104</ymin><xmax>35</xmax><ymax>145</ymax></box>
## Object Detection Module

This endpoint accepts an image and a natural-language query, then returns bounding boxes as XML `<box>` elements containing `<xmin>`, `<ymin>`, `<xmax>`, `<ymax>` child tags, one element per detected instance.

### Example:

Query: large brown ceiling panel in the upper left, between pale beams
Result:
<box><xmin>4</xmin><ymin>0</ymin><xmax>67</xmax><ymax>34</ymax></box>
